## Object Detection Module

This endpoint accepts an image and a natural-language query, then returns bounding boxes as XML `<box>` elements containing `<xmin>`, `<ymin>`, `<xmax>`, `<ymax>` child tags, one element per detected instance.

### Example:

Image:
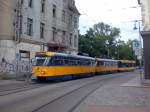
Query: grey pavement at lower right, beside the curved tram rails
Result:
<box><xmin>74</xmin><ymin>72</ymin><xmax>150</xmax><ymax>112</ymax></box>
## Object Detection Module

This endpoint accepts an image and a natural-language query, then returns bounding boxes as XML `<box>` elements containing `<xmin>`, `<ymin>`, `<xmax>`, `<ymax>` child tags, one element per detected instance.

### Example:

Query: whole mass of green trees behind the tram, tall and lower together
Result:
<box><xmin>79</xmin><ymin>23</ymin><xmax>134</xmax><ymax>60</ymax></box>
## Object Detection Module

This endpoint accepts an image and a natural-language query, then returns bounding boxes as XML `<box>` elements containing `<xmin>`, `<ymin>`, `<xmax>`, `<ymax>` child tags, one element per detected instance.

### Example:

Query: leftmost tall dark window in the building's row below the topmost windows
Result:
<box><xmin>27</xmin><ymin>18</ymin><xmax>33</xmax><ymax>36</ymax></box>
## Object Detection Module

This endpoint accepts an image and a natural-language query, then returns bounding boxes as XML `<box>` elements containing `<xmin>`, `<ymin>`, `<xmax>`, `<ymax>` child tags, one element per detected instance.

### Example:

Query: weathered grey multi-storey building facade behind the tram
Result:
<box><xmin>0</xmin><ymin>0</ymin><xmax>80</xmax><ymax>61</ymax></box>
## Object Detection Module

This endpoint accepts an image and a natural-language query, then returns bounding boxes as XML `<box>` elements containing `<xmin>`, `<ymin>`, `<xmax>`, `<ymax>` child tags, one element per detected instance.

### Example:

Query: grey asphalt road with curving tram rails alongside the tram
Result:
<box><xmin>0</xmin><ymin>73</ymin><xmax>136</xmax><ymax>112</ymax></box>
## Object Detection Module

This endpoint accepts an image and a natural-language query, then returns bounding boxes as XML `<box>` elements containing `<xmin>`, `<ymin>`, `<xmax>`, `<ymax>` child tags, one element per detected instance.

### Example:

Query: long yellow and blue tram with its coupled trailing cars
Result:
<box><xmin>32</xmin><ymin>52</ymin><xmax>135</xmax><ymax>80</ymax></box>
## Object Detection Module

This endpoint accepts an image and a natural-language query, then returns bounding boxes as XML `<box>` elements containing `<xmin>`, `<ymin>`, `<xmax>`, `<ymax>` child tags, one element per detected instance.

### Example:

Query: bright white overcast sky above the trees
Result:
<box><xmin>76</xmin><ymin>0</ymin><xmax>141</xmax><ymax>41</ymax></box>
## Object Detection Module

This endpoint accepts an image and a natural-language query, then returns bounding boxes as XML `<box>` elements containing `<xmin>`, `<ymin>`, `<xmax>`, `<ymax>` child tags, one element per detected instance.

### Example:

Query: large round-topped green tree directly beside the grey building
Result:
<box><xmin>79</xmin><ymin>22</ymin><xmax>120</xmax><ymax>58</ymax></box>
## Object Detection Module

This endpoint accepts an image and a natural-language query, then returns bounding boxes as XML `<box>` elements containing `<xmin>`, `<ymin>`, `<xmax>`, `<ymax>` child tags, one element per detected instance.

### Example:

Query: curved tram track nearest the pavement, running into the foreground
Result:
<box><xmin>32</xmin><ymin>75</ymin><xmax>121</xmax><ymax>112</ymax></box>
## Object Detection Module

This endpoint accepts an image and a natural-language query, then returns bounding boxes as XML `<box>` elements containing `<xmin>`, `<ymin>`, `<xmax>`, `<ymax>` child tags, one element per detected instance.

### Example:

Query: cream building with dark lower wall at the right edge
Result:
<box><xmin>138</xmin><ymin>0</ymin><xmax>150</xmax><ymax>80</ymax></box>
